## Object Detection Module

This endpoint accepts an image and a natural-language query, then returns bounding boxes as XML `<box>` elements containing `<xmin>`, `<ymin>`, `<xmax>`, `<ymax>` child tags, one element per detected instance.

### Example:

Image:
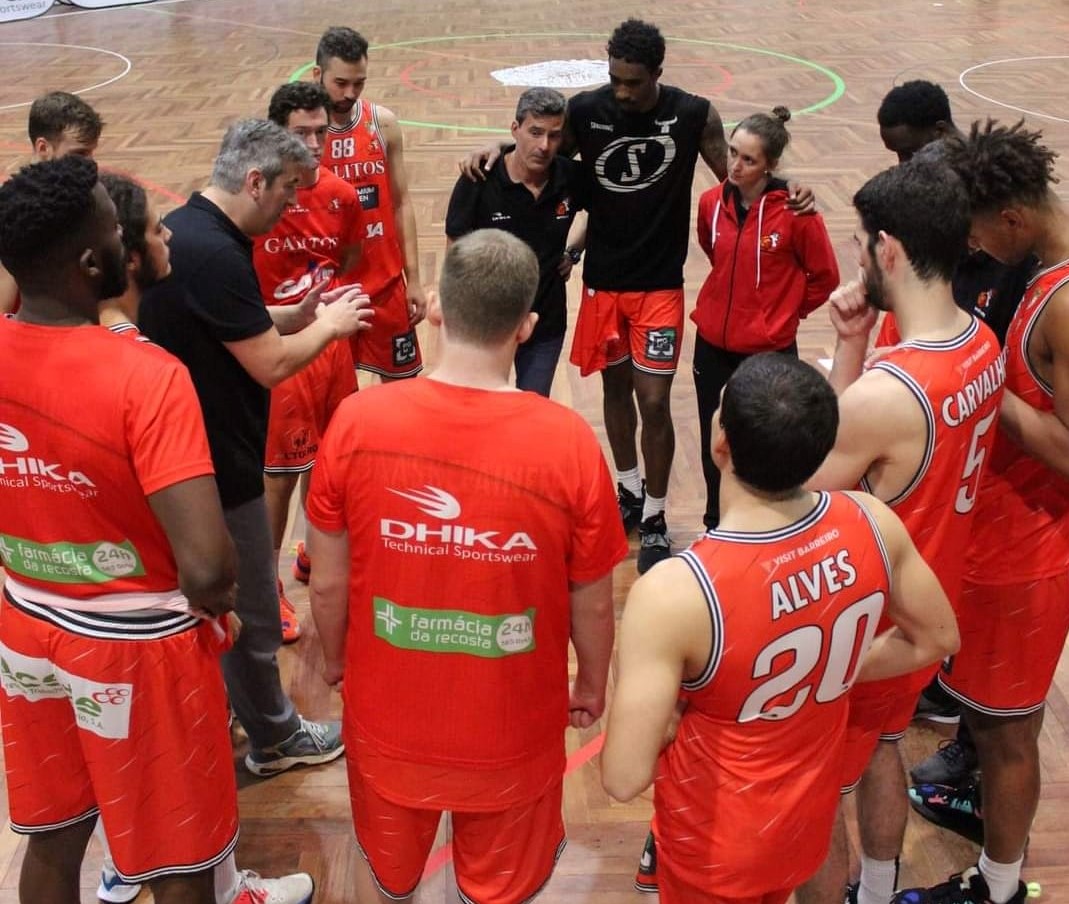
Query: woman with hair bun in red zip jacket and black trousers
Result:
<box><xmin>691</xmin><ymin>107</ymin><xmax>839</xmax><ymax>529</ymax></box>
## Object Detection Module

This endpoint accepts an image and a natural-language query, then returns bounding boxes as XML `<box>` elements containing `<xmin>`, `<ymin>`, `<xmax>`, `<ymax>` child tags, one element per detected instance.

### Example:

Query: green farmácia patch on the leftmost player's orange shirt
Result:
<box><xmin>0</xmin><ymin>533</ymin><xmax>144</xmax><ymax>583</ymax></box>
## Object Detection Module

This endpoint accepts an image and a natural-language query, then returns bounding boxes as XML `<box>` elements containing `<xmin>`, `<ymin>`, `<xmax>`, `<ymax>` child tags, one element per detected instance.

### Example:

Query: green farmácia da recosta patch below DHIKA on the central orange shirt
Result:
<box><xmin>373</xmin><ymin>596</ymin><xmax>535</xmax><ymax>659</ymax></box>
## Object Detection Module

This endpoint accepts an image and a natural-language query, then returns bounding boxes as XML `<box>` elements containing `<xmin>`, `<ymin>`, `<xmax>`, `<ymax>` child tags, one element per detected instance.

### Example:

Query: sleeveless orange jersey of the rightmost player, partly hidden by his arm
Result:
<box><xmin>967</xmin><ymin>262</ymin><xmax>1069</xmax><ymax>583</ymax></box>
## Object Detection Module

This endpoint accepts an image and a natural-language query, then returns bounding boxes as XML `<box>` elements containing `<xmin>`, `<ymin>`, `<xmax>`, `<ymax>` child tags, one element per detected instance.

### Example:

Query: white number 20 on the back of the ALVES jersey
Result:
<box><xmin>738</xmin><ymin>592</ymin><xmax>884</xmax><ymax>722</ymax></box>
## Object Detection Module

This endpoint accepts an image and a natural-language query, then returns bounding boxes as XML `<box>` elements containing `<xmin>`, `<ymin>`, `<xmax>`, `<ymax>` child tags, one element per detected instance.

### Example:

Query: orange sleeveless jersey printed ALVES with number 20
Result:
<box><xmin>654</xmin><ymin>493</ymin><xmax>890</xmax><ymax>900</ymax></box>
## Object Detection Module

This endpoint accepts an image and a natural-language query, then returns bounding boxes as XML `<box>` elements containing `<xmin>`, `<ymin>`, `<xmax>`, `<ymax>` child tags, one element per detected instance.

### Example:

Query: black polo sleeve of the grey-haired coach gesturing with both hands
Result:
<box><xmin>188</xmin><ymin>245</ymin><xmax>275</xmax><ymax>342</ymax></box>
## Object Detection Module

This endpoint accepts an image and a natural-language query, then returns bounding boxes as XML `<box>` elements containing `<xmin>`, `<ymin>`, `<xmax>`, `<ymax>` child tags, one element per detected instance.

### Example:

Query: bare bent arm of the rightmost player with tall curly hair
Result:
<box><xmin>998</xmin><ymin>289</ymin><xmax>1069</xmax><ymax>480</ymax></box>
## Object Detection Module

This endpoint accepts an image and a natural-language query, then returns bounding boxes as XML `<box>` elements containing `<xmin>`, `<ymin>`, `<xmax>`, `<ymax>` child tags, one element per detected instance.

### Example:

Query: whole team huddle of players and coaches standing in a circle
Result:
<box><xmin>0</xmin><ymin>12</ymin><xmax>1069</xmax><ymax>904</ymax></box>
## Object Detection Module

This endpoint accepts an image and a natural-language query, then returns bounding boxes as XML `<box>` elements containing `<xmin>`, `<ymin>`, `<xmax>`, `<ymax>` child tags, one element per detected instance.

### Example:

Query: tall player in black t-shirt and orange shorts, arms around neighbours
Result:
<box><xmin>470</xmin><ymin>19</ymin><xmax>727</xmax><ymax>572</ymax></box>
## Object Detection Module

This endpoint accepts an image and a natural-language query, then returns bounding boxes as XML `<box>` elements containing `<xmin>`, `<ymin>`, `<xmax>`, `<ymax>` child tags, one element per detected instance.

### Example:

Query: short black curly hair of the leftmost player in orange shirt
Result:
<box><xmin>0</xmin><ymin>155</ymin><xmax>98</xmax><ymax>282</ymax></box>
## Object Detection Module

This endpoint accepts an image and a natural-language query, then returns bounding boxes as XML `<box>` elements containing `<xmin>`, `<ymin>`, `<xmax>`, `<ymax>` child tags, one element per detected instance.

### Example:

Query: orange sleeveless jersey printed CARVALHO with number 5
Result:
<box><xmin>862</xmin><ymin>317</ymin><xmax>1006</xmax><ymax>606</ymax></box>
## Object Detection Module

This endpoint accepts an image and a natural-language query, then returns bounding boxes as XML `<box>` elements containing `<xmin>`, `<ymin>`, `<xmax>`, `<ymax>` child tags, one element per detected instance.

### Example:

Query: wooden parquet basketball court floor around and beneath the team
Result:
<box><xmin>0</xmin><ymin>0</ymin><xmax>1069</xmax><ymax>904</ymax></box>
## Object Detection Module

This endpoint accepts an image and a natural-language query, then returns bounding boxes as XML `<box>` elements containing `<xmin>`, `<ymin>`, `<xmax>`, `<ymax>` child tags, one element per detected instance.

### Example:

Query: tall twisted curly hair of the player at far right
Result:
<box><xmin>944</xmin><ymin>120</ymin><xmax>1058</xmax><ymax>214</ymax></box>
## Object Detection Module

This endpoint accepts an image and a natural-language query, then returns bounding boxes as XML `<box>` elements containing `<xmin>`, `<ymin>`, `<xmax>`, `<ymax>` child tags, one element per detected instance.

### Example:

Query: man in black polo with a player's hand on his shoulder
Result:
<box><xmin>446</xmin><ymin>88</ymin><xmax>587</xmax><ymax>395</ymax></box>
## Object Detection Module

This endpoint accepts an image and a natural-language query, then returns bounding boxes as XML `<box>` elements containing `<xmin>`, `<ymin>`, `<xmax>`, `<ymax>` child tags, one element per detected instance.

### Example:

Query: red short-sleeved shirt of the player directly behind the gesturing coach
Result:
<box><xmin>252</xmin><ymin>169</ymin><xmax>365</xmax><ymax>305</ymax></box>
